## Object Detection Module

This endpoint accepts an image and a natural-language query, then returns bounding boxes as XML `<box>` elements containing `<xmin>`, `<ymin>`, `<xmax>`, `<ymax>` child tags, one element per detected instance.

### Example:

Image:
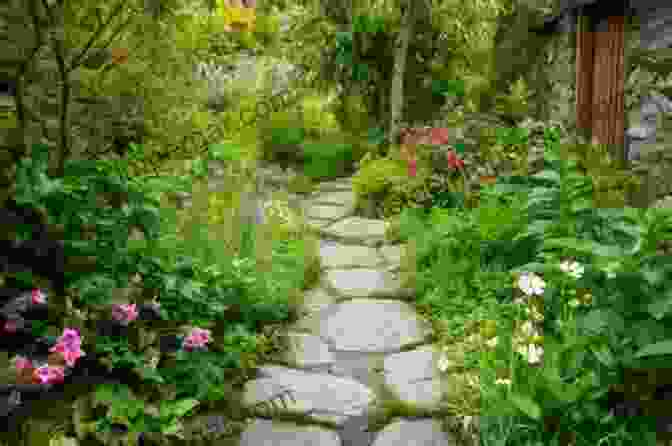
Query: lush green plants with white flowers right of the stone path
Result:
<box><xmin>400</xmin><ymin>129</ymin><xmax>672</xmax><ymax>445</ymax></box>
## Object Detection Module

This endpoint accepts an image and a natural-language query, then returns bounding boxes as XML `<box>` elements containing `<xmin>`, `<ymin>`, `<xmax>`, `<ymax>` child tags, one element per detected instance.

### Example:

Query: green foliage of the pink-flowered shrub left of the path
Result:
<box><xmin>4</xmin><ymin>146</ymin><xmax>304</xmax><ymax>442</ymax></box>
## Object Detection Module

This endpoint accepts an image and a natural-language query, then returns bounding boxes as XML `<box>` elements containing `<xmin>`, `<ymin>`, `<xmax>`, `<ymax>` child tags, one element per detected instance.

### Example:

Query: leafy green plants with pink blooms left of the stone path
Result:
<box><xmin>0</xmin><ymin>145</ymin><xmax>316</xmax><ymax>442</ymax></box>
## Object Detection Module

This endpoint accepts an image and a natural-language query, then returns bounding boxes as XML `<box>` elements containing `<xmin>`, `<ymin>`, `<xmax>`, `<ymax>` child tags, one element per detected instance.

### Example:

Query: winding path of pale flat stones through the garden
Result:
<box><xmin>234</xmin><ymin>169</ymin><xmax>476</xmax><ymax>446</ymax></box>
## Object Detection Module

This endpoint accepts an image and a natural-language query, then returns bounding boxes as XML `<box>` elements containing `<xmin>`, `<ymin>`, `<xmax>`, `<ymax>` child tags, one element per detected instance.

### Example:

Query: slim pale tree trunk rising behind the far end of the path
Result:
<box><xmin>390</xmin><ymin>0</ymin><xmax>417</xmax><ymax>144</ymax></box>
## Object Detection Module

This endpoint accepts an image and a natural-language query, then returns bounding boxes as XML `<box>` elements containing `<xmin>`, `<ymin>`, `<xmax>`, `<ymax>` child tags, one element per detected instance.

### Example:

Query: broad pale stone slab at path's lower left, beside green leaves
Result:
<box><xmin>242</xmin><ymin>365</ymin><xmax>375</xmax><ymax>426</ymax></box>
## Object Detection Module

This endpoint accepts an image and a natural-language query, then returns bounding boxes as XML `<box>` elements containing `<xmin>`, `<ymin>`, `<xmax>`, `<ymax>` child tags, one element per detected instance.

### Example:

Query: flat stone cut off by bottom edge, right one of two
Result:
<box><xmin>372</xmin><ymin>418</ymin><xmax>459</xmax><ymax>446</ymax></box>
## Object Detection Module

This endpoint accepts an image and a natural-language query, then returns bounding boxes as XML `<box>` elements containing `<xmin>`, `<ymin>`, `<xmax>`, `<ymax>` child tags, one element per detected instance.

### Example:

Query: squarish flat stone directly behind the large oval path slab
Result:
<box><xmin>323</xmin><ymin>268</ymin><xmax>413</xmax><ymax>299</ymax></box>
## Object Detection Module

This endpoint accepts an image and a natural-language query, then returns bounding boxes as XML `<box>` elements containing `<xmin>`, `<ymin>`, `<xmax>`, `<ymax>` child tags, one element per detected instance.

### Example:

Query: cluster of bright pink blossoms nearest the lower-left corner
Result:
<box><xmin>14</xmin><ymin>328</ymin><xmax>85</xmax><ymax>384</ymax></box>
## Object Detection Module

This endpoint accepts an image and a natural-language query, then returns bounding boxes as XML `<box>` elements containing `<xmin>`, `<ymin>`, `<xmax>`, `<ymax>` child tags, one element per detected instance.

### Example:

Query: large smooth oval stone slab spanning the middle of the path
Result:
<box><xmin>319</xmin><ymin>299</ymin><xmax>431</xmax><ymax>353</ymax></box>
